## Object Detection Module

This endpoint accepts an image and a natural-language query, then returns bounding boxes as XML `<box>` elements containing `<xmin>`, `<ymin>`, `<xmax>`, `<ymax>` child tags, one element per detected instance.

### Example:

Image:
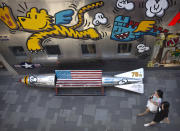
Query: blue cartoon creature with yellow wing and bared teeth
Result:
<box><xmin>110</xmin><ymin>16</ymin><xmax>169</xmax><ymax>42</ymax></box>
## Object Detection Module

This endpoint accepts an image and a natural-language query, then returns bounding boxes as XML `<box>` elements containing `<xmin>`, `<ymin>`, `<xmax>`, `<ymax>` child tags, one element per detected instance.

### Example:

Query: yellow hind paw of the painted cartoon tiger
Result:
<box><xmin>87</xmin><ymin>28</ymin><xmax>101</xmax><ymax>40</ymax></box>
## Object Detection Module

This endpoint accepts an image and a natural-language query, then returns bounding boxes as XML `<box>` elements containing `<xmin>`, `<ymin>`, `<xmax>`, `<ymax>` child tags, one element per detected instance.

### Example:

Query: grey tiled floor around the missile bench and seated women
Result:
<box><xmin>0</xmin><ymin>70</ymin><xmax>180</xmax><ymax>131</ymax></box>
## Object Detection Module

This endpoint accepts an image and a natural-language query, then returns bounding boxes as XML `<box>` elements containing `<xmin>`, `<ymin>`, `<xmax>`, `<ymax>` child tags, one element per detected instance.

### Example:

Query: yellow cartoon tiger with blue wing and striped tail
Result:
<box><xmin>0</xmin><ymin>1</ymin><xmax>104</xmax><ymax>52</ymax></box>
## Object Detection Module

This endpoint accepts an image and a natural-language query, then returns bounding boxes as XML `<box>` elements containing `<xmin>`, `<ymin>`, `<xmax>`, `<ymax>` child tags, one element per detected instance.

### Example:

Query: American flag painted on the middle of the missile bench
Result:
<box><xmin>55</xmin><ymin>70</ymin><xmax>102</xmax><ymax>87</ymax></box>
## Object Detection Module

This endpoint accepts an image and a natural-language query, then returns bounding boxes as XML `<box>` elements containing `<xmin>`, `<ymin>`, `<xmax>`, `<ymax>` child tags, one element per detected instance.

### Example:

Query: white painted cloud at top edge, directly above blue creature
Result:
<box><xmin>116</xmin><ymin>0</ymin><xmax>134</xmax><ymax>10</ymax></box>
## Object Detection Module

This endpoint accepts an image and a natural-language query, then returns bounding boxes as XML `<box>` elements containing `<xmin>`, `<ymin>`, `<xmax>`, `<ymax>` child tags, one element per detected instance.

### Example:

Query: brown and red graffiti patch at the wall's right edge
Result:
<box><xmin>147</xmin><ymin>33</ymin><xmax>180</xmax><ymax>67</ymax></box>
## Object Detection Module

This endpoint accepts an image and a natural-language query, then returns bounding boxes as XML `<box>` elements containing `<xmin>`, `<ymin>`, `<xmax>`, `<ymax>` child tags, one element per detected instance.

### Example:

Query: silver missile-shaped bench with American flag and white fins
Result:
<box><xmin>20</xmin><ymin>68</ymin><xmax>144</xmax><ymax>94</ymax></box>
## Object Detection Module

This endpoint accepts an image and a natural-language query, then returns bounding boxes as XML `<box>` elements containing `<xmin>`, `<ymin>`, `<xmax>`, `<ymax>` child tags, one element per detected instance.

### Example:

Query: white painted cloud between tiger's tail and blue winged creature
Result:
<box><xmin>92</xmin><ymin>13</ymin><xmax>108</xmax><ymax>26</ymax></box>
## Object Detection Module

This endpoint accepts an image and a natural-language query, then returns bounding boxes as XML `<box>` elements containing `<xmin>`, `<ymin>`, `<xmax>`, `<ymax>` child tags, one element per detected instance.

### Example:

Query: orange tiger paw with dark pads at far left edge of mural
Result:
<box><xmin>0</xmin><ymin>3</ymin><xmax>18</xmax><ymax>30</ymax></box>
